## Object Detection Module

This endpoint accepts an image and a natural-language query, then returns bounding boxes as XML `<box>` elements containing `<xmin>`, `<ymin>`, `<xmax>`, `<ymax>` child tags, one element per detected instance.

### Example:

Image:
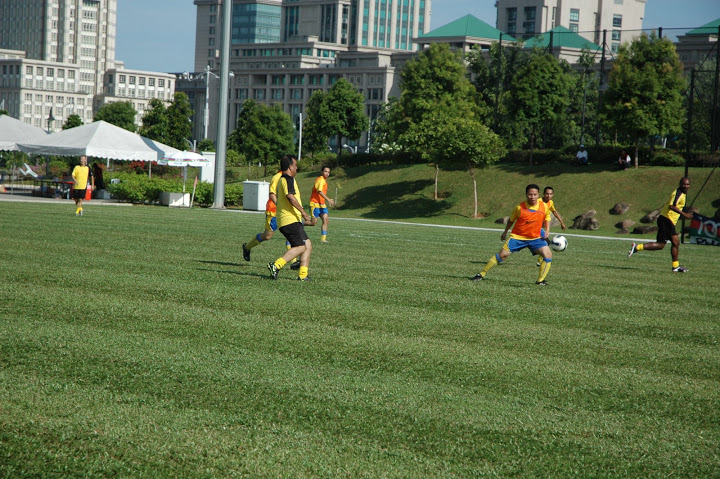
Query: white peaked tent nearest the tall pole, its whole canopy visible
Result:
<box><xmin>18</xmin><ymin>121</ymin><xmax>179</xmax><ymax>161</ymax></box>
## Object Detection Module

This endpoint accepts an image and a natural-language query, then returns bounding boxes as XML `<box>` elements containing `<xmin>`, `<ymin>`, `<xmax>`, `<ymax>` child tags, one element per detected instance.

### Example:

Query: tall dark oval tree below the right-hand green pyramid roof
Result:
<box><xmin>508</xmin><ymin>53</ymin><xmax>570</xmax><ymax>165</ymax></box>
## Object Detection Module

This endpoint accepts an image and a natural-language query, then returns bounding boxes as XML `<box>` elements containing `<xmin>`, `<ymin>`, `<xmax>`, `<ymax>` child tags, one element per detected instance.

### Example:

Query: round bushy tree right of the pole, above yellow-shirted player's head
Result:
<box><xmin>228</xmin><ymin>100</ymin><xmax>294</xmax><ymax>176</ymax></box>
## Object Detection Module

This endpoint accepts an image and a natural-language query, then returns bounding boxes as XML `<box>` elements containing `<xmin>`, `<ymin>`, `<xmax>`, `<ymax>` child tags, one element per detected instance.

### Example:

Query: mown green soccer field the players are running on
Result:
<box><xmin>0</xmin><ymin>202</ymin><xmax>720</xmax><ymax>478</ymax></box>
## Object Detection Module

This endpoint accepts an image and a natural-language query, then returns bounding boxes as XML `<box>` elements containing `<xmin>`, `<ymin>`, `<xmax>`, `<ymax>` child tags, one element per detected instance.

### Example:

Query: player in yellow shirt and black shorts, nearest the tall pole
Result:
<box><xmin>268</xmin><ymin>156</ymin><xmax>317</xmax><ymax>281</ymax></box>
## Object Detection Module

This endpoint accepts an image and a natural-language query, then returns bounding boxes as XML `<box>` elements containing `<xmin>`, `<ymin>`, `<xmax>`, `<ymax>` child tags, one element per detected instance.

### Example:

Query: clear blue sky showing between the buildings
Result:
<box><xmin>115</xmin><ymin>0</ymin><xmax>720</xmax><ymax>72</ymax></box>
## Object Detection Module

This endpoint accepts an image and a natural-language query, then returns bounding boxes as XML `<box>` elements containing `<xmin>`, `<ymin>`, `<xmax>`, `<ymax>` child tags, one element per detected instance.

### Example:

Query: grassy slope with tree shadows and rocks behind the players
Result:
<box><xmin>290</xmin><ymin>164</ymin><xmax>720</xmax><ymax>237</ymax></box>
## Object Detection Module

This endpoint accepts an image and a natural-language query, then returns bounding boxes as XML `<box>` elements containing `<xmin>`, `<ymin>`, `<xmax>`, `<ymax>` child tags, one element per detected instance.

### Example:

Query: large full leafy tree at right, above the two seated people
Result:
<box><xmin>605</xmin><ymin>33</ymin><xmax>685</xmax><ymax>168</ymax></box>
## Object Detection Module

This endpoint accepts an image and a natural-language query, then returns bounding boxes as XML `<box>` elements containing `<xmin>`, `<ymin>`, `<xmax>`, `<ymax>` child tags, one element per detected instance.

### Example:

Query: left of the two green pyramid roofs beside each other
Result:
<box><xmin>413</xmin><ymin>15</ymin><xmax>516</xmax><ymax>52</ymax></box>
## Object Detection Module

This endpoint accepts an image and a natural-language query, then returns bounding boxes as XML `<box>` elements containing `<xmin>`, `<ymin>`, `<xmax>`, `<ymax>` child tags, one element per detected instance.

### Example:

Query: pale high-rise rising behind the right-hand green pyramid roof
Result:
<box><xmin>495</xmin><ymin>0</ymin><xmax>646</xmax><ymax>51</ymax></box>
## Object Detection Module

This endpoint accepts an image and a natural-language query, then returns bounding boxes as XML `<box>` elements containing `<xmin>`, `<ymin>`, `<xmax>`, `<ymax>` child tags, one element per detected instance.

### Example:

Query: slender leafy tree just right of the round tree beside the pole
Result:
<box><xmin>320</xmin><ymin>78</ymin><xmax>368</xmax><ymax>162</ymax></box>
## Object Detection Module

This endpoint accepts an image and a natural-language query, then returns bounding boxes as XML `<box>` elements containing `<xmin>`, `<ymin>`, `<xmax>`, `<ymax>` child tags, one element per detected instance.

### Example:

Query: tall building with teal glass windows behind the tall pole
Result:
<box><xmin>188</xmin><ymin>0</ymin><xmax>431</xmax><ymax>145</ymax></box>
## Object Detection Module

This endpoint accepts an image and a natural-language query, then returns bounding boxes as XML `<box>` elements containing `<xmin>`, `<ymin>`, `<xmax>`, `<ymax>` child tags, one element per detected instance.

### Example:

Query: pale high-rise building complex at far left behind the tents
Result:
<box><xmin>0</xmin><ymin>0</ymin><xmax>175</xmax><ymax>131</ymax></box>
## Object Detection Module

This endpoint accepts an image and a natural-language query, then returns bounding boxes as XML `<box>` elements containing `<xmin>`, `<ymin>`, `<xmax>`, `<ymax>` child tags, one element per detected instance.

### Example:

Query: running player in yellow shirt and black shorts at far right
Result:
<box><xmin>628</xmin><ymin>177</ymin><xmax>692</xmax><ymax>273</ymax></box>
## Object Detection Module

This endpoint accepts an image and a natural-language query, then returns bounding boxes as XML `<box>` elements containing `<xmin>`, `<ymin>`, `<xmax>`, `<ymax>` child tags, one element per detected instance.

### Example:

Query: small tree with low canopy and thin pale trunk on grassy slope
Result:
<box><xmin>434</xmin><ymin>117</ymin><xmax>507</xmax><ymax>218</ymax></box>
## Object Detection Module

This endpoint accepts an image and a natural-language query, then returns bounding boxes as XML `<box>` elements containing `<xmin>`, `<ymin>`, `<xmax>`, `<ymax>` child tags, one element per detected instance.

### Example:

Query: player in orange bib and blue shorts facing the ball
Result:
<box><xmin>470</xmin><ymin>184</ymin><xmax>552</xmax><ymax>286</ymax></box>
